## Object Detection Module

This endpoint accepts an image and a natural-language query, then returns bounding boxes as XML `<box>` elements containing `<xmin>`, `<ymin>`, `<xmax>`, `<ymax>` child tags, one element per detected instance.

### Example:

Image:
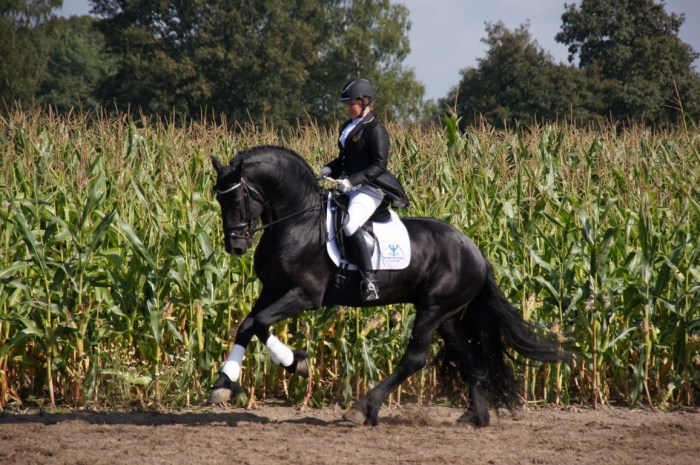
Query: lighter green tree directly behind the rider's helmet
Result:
<box><xmin>304</xmin><ymin>0</ymin><xmax>425</xmax><ymax>124</ymax></box>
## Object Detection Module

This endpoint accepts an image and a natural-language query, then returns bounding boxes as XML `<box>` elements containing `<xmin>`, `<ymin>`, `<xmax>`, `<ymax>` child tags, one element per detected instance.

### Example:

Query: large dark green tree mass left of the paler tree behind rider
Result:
<box><xmin>89</xmin><ymin>0</ymin><xmax>323</xmax><ymax>124</ymax></box>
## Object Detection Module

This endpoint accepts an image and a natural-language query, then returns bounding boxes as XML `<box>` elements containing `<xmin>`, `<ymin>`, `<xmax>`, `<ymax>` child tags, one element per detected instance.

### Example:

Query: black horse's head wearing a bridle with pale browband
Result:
<box><xmin>211</xmin><ymin>156</ymin><xmax>265</xmax><ymax>255</ymax></box>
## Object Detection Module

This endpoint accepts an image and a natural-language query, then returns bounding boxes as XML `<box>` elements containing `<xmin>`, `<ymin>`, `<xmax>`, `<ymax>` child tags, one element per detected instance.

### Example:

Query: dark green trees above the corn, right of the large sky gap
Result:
<box><xmin>440</xmin><ymin>0</ymin><xmax>700</xmax><ymax>128</ymax></box>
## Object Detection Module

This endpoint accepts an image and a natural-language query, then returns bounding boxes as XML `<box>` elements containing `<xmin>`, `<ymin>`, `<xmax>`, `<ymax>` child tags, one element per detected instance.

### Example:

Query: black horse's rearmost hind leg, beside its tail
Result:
<box><xmin>438</xmin><ymin>313</ymin><xmax>491</xmax><ymax>428</ymax></box>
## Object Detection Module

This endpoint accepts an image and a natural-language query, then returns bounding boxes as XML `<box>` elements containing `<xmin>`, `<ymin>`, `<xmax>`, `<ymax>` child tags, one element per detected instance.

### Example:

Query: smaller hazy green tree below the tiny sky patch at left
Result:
<box><xmin>36</xmin><ymin>15</ymin><xmax>114</xmax><ymax>113</ymax></box>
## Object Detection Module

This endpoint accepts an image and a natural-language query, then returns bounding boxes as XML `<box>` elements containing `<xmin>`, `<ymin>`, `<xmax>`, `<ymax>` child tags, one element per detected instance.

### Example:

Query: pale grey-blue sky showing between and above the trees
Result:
<box><xmin>59</xmin><ymin>0</ymin><xmax>700</xmax><ymax>99</ymax></box>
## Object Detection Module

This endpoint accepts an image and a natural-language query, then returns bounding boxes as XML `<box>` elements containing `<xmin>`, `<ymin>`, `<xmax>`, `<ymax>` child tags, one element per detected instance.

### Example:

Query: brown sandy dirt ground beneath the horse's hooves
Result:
<box><xmin>0</xmin><ymin>403</ymin><xmax>700</xmax><ymax>465</ymax></box>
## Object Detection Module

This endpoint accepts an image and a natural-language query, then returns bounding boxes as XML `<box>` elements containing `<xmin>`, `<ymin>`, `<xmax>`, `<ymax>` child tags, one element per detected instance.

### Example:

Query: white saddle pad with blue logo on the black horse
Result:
<box><xmin>326</xmin><ymin>196</ymin><xmax>411</xmax><ymax>270</ymax></box>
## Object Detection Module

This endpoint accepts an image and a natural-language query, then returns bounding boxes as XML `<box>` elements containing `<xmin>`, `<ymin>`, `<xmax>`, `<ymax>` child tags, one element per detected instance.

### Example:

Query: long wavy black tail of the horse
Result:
<box><xmin>437</xmin><ymin>258</ymin><xmax>568</xmax><ymax>406</ymax></box>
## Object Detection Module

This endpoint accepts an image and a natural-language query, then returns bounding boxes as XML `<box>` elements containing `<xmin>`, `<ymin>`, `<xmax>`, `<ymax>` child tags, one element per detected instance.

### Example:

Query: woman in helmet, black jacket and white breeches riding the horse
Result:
<box><xmin>319</xmin><ymin>78</ymin><xmax>409</xmax><ymax>301</ymax></box>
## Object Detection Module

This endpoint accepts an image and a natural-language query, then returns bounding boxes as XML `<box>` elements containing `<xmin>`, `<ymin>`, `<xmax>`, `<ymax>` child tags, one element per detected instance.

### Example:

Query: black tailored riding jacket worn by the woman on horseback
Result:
<box><xmin>326</xmin><ymin>111</ymin><xmax>409</xmax><ymax>208</ymax></box>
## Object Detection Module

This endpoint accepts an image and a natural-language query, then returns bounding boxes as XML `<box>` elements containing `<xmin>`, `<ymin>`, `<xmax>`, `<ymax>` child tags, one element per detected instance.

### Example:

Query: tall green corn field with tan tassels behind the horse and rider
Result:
<box><xmin>0</xmin><ymin>111</ymin><xmax>700</xmax><ymax>409</ymax></box>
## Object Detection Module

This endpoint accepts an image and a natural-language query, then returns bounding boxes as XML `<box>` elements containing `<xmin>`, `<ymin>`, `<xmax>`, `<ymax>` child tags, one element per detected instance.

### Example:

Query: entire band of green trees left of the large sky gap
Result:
<box><xmin>0</xmin><ymin>0</ymin><xmax>424</xmax><ymax>128</ymax></box>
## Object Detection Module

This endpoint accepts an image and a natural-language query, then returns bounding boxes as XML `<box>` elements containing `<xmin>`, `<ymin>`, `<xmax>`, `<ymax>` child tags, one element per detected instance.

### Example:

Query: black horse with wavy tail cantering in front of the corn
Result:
<box><xmin>210</xmin><ymin>146</ymin><xmax>565</xmax><ymax>426</ymax></box>
